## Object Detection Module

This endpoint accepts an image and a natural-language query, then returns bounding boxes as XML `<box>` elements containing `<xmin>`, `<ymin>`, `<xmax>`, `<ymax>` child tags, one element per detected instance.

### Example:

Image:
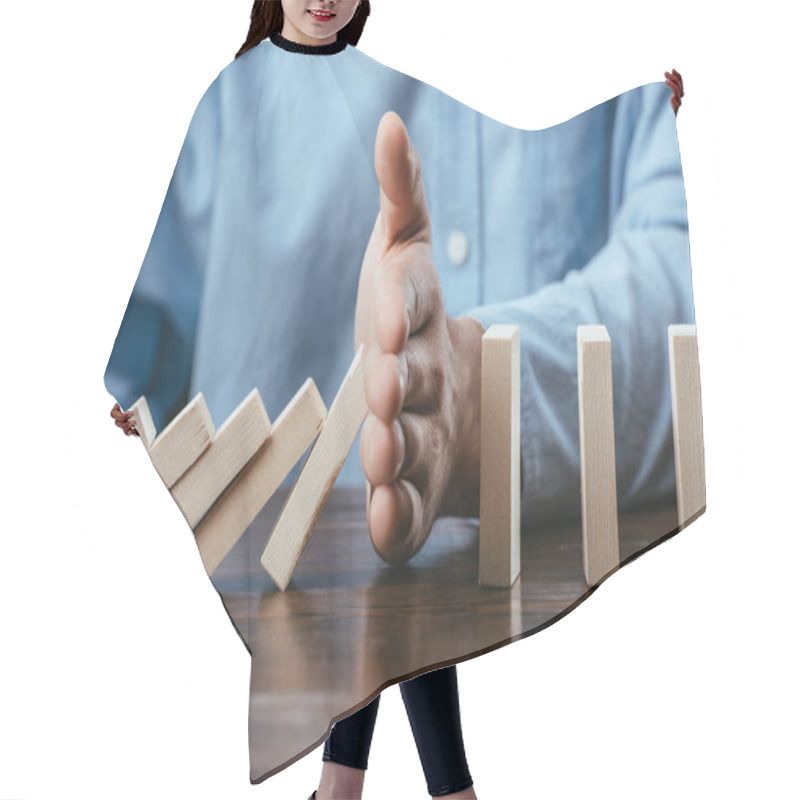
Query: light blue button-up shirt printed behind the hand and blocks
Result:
<box><xmin>105</xmin><ymin>40</ymin><xmax>694</xmax><ymax>523</ymax></box>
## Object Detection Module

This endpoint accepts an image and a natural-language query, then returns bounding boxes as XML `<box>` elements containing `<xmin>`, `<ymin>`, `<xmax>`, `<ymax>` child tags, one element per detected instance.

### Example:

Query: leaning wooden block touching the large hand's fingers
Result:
<box><xmin>261</xmin><ymin>345</ymin><xmax>367</xmax><ymax>591</ymax></box>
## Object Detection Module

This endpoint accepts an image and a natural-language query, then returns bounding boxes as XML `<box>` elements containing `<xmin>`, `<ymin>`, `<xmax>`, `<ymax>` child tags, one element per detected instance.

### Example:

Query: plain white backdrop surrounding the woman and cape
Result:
<box><xmin>0</xmin><ymin>0</ymin><xmax>800</xmax><ymax>800</ymax></box>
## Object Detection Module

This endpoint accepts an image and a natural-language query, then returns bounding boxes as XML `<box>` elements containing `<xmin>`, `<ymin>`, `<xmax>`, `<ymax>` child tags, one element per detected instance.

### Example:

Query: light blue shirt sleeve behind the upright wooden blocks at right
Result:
<box><xmin>467</xmin><ymin>84</ymin><xmax>694</xmax><ymax>524</ymax></box>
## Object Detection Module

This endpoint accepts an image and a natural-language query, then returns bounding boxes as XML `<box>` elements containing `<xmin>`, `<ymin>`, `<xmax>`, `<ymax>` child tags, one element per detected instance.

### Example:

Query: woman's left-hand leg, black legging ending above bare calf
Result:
<box><xmin>316</xmin><ymin>695</ymin><xmax>381</xmax><ymax>800</ymax></box>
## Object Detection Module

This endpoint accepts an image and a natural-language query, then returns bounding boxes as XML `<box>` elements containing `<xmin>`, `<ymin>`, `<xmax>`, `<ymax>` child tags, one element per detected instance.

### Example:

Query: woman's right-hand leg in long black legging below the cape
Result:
<box><xmin>400</xmin><ymin>667</ymin><xmax>475</xmax><ymax>798</ymax></box>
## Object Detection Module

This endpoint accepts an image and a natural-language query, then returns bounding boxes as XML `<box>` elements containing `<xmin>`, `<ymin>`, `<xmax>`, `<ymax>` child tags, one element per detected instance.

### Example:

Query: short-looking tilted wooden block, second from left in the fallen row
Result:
<box><xmin>149</xmin><ymin>394</ymin><xmax>214</xmax><ymax>489</ymax></box>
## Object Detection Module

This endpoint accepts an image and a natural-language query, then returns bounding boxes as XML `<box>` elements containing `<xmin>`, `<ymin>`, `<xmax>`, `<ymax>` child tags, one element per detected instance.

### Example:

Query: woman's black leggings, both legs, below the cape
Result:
<box><xmin>322</xmin><ymin>667</ymin><xmax>472</xmax><ymax>797</ymax></box>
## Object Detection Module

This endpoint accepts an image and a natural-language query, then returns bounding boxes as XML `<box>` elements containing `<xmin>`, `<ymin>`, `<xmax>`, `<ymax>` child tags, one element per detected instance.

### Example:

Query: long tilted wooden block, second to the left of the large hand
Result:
<box><xmin>195</xmin><ymin>378</ymin><xmax>325</xmax><ymax>575</ymax></box>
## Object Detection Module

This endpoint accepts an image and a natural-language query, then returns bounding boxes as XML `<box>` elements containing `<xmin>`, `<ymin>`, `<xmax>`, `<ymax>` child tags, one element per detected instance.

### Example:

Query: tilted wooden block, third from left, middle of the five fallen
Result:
<box><xmin>172</xmin><ymin>389</ymin><xmax>271</xmax><ymax>528</ymax></box>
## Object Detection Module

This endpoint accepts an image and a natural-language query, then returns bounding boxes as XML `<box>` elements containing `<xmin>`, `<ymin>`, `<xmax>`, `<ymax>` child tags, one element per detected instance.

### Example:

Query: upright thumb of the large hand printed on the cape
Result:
<box><xmin>375</xmin><ymin>111</ymin><xmax>430</xmax><ymax>246</ymax></box>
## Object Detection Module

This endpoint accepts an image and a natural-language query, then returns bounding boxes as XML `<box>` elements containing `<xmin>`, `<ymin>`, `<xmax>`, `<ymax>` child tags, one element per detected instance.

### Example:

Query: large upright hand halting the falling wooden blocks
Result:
<box><xmin>355</xmin><ymin>112</ymin><xmax>483</xmax><ymax>563</ymax></box>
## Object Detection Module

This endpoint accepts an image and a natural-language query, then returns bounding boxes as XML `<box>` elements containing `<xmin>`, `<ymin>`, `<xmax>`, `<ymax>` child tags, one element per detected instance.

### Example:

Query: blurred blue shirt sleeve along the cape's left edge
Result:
<box><xmin>104</xmin><ymin>79</ymin><xmax>220</xmax><ymax>430</ymax></box>
